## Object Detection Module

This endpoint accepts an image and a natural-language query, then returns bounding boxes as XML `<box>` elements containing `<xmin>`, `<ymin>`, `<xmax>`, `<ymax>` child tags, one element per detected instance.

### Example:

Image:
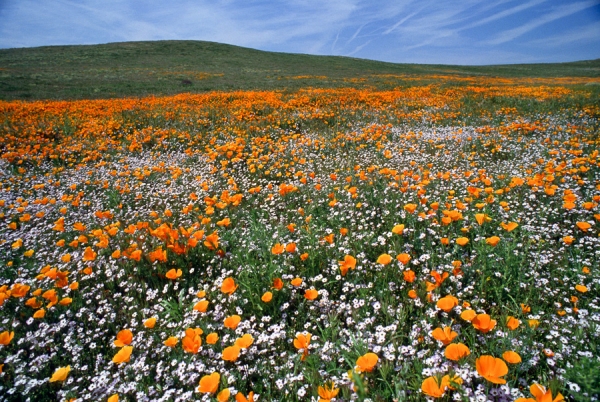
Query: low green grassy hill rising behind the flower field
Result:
<box><xmin>0</xmin><ymin>41</ymin><xmax>600</xmax><ymax>100</ymax></box>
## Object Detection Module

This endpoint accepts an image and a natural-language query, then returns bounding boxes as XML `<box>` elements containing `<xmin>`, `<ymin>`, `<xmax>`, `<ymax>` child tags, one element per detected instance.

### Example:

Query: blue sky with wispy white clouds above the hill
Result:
<box><xmin>0</xmin><ymin>0</ymin><xmax>600</xmax><ymax>64</ymax></box>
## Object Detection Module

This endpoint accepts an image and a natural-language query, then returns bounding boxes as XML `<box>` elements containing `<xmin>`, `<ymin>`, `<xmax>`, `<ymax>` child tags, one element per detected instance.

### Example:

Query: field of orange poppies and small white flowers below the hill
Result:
<box><xmin>0</xmin><ymin>76</ymin><xmax>600</xmax><ymax>402</ymax></box>
